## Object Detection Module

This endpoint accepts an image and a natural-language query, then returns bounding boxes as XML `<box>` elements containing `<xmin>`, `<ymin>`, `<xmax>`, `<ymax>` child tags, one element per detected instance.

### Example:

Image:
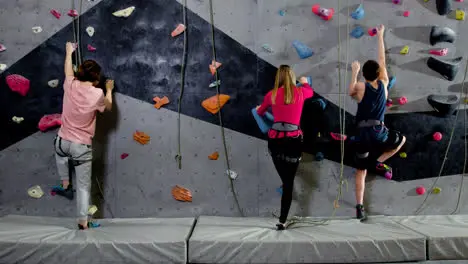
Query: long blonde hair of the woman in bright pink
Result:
<box><xmin>271</xmin><ymin>65</ymin><xmax>296</xmax><ymax>104</ymax></box>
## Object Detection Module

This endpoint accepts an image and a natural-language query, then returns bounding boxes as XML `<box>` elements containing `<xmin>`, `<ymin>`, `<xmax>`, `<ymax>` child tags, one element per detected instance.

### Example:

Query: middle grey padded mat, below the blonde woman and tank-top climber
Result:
<box><xmin>189</xmin><ymin>216</ymin><xmax>426</xmax><ymax>263</ymax></box>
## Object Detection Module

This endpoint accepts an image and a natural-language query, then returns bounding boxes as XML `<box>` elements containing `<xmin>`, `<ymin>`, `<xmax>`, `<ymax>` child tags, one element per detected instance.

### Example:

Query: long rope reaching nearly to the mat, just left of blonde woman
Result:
<box><xmin>210</xmin><ymin>0</ymin><xmax>244</xmax><ymax>216</ymax></box>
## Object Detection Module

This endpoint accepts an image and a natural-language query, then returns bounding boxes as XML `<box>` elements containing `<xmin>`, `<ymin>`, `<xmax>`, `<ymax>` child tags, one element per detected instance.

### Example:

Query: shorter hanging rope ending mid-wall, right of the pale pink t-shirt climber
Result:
<box><xmin>176</xmin><ymin>0</ymin><xmax>187</xmax><ymax>170</ymax></box>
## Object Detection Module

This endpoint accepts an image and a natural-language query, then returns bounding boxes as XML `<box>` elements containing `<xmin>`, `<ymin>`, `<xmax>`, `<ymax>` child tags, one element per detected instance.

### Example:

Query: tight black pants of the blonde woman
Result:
<box><xmin>268</xmin><ymin>137</ymin><xmax>302</xmax><ymax>223</ymax></box>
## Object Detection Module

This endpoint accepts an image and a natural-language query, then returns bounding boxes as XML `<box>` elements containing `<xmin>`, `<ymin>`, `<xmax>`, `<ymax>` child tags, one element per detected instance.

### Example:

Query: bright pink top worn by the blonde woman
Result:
<box><xmin>257</xmin><ymin>84</ymin><xmax>314</xmax><ymax>136</ymax></box>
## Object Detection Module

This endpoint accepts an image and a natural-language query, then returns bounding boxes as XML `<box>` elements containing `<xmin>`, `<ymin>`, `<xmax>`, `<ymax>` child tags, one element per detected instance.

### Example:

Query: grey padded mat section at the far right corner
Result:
<box><xmin>390</xmin><ymin>215</ymin><xmax>468</xmax><ymax>262</ymax></box>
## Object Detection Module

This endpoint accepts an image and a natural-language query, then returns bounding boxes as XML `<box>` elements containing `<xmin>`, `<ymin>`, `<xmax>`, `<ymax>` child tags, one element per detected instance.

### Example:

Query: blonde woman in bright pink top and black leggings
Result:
<box><xmin>257</xmin><ymin>65</ymin><xmax>314</xmax><ymax>230</ymax></box>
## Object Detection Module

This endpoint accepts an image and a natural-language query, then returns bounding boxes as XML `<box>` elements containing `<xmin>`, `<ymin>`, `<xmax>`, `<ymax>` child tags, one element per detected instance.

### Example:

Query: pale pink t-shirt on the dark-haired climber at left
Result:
<box><xmin>58</xmin><ymin>76</ymin><xmax>106</xmax><ymax>145</ymax></box>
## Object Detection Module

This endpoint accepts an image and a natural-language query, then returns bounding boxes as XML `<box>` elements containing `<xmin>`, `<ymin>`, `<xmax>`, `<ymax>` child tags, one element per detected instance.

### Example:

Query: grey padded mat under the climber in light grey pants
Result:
<box><xmin>0</xmin><ymin>216</ymin><xmax>194</xmax><ymax>264</ymax></box>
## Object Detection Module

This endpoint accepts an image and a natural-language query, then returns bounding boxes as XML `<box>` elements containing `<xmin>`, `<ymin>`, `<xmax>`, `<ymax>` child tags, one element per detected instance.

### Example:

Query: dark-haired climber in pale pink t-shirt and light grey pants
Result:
<box><xmin>52</xmin><ymin>43</ymin><xmax>114</xmax><ymax>229</ymax></box>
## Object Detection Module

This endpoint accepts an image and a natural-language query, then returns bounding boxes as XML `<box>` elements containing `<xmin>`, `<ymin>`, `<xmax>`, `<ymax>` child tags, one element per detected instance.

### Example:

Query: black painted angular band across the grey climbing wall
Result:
<box><xmin>0</xmin><ymin>0</ymin><xmax>464</xmax><ymax>180</ymax></box>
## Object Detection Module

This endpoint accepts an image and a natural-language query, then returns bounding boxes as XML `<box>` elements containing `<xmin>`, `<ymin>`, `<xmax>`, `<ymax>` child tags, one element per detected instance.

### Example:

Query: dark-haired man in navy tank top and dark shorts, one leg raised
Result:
<box><xmin>349</xmin><ymin>25</ymin><xmax>406</xmax><ymax>219</ymax></box>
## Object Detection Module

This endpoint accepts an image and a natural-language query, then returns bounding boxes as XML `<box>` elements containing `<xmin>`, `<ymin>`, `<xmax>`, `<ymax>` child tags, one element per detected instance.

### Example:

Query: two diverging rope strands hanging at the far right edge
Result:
<box><xmin>415</xmin><ymin>60</ymin><xmax>468</xmax><ymax>215</ymax></box>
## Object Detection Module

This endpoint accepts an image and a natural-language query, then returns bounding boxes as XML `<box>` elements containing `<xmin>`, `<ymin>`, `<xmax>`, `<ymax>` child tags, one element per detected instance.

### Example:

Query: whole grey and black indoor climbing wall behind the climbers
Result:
<box><xmin>0</xmin><ymin>0</ymin><xmax>468</xmax><ymax>221</ymax></box>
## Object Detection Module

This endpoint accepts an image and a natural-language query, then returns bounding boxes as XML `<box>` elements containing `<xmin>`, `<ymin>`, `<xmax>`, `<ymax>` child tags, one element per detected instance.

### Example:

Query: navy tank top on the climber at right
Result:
<box><xmin>356</xmin><ymin>81</ymin><xmax>387</xmax><ymax>122</ymax></box>
